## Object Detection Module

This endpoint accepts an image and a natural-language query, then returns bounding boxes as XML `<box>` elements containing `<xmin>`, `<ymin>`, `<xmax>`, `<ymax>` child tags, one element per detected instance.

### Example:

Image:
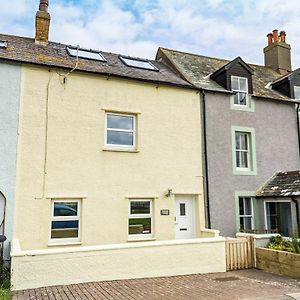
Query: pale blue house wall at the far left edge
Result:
<box><xmin>0</xmin><ymin>63</ymin><xmax>21</xmax><ymax>259</ymax></box>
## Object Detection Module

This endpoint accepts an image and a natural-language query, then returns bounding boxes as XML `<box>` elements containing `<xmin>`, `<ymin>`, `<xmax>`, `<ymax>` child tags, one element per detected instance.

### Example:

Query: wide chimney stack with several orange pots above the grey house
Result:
<box><xmin>264</xmin><ymin>29</ymin><xmax>292</xmax><ymax>75</ymax></box>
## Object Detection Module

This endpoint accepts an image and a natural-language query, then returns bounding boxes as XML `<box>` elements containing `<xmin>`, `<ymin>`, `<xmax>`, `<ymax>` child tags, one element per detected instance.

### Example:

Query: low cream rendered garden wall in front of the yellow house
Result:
<box><xmin>11</xmin><ymin>237</ymin><xmax>226</xmax><ymax>290</ymax></box>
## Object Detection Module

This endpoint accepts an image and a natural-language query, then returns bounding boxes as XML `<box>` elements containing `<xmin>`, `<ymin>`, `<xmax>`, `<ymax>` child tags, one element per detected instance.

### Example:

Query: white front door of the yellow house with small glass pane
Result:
<box><xmin>175</xmin><ymin>195</ymin><xmax>195</xmax><ymax>239</ymax></box>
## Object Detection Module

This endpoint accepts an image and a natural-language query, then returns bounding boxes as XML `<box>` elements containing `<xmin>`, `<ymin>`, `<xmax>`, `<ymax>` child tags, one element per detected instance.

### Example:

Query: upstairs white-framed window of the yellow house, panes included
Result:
<box><xmin>105</xmin><ymin>112</ymin><xmax>136</xmax><ymax>149</ymax></box>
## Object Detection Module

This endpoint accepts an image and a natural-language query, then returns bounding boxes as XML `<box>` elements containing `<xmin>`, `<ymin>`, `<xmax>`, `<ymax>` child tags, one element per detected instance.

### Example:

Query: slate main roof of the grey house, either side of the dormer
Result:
<box><xmin>157</xmin><ymin>48</ymin><xmax>298</xmax><ymax>102</ymax></box>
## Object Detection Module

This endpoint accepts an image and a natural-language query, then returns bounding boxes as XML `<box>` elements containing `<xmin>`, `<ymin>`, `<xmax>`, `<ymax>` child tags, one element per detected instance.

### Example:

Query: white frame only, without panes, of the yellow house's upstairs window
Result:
<box><xmin>104</xmin><ymin>110</ymin><xmax>137</xmax><ymax>151</ymax></box>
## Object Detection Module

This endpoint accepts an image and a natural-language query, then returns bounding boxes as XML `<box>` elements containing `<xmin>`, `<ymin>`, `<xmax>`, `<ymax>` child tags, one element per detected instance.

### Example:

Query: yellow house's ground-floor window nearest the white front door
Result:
<box><xmin>128</xmin><ymin>199</ymin><xmax>153</xmax><ymax>239</ymax></box>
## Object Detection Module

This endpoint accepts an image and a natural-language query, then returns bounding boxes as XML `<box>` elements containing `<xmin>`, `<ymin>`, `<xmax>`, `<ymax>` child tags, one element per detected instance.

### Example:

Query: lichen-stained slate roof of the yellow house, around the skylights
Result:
<box><xmin>0</xmin><ymin>34</ymin><xmax>193</xmax><ymax>88</ymax></box>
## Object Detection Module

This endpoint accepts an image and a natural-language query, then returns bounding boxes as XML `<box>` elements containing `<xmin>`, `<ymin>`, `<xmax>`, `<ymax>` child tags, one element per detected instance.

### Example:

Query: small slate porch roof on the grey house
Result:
<box><xmin>256</xmin><ymin>171</ymin><xmax>300</xmax><ymax>197</ymax></box>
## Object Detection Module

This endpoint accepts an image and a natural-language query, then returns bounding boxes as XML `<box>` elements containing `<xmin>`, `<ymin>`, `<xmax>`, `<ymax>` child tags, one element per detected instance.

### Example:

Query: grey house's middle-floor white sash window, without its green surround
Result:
<box><xmin>235</xmin><ymin>131</ymin><xmax>251</xmax><ymax>170</ymax></box>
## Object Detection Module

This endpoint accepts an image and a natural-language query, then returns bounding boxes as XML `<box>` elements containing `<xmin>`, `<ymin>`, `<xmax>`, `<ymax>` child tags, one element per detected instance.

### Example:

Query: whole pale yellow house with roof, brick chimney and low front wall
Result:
<box><xmin>0</xmin><ymin>1</ymin><xmax>225</xmax><ymax>290</ymax></box>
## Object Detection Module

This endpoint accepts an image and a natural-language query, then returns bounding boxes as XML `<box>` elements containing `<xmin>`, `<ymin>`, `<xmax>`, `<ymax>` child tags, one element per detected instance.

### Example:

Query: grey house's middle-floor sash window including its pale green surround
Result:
<box><xmin>231</xmin><ymin>126</ymin><xmax>257</xmax><ymax>175</ymax></box>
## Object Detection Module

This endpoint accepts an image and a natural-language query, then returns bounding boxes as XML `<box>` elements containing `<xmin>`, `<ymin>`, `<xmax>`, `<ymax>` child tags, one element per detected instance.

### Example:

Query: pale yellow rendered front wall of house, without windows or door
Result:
<box><xmin>14</xmin><ymin>66</ymin><xmax>204</xmax><ymax>250</ymax></box>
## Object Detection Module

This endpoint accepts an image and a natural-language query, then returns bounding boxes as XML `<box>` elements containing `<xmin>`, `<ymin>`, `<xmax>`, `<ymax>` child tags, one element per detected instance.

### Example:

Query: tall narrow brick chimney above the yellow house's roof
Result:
<box><xmin>35</xmin><ymin>0</ymin><xmax>50</xmax><ymax>46</ymax></box>
